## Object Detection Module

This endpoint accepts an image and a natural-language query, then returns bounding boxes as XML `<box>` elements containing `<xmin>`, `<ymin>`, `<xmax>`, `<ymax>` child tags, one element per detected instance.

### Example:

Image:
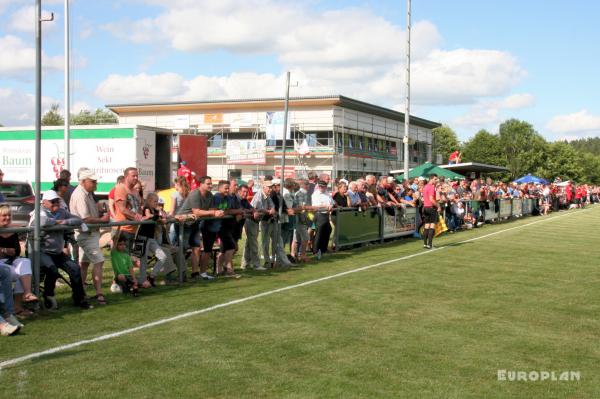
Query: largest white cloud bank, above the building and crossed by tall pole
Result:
<box><xmin>104</xmin><ymin>0</ymin><xmax>526</xmax><ymax>106</ymax></box>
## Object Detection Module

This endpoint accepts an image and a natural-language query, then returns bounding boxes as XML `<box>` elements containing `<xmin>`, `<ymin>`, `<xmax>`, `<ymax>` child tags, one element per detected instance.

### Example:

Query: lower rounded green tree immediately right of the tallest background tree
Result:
<box><xmin>532</xmin><ymin>141</ymin><xmax>591</xmax><ymax>181</ymax></box>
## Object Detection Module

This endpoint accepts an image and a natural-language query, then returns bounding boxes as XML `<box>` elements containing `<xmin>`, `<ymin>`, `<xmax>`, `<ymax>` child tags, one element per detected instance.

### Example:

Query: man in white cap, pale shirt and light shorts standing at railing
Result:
<box><xmin>69</xmin><ymin>168</ymin><xmax>109</xmax><ymax>305</ymax></box>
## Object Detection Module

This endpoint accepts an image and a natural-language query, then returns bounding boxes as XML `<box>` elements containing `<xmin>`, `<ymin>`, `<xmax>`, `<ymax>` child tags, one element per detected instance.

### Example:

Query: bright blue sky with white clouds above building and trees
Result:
<box><xmin>0</xmin><ymin>0</ymin><xmax>600</xmax><ymax>141</ymax></box>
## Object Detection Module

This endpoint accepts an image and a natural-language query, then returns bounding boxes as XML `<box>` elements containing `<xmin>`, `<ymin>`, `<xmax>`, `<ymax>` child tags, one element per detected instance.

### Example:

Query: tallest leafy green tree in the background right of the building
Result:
<box><xmin>499</xmin><ymin>119</ymin><xmax>548</xmax><ymax>178</ymax></box>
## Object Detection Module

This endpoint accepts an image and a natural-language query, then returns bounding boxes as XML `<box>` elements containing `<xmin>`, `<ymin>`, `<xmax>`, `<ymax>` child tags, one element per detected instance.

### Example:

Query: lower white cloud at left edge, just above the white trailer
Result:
<box><xmin>0</xmin><ymin>88</ymin><xmax>59</xmax><ymax>126</ymax></box>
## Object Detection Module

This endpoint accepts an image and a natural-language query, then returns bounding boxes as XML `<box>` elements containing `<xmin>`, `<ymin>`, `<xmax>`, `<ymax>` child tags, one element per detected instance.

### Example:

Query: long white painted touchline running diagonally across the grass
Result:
<box><xmin>0</xmin><ymin>208</ymin><xmax>592</xmax><ymax>370</ymax></box>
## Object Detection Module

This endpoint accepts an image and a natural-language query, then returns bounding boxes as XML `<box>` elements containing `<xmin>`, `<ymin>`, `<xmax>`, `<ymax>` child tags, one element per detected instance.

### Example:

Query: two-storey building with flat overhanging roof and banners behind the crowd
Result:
<box><xmin>107</xmin><ymin>95</ymin><xmax>440</xmax><ymax>179</ymax></box>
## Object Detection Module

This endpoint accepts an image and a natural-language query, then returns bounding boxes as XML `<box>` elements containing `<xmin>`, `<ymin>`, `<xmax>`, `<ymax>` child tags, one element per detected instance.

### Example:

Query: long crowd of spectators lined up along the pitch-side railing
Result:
<box><xmin>0</xmin><ymin>165</ymin><xmax>599</xmax><ymax>335</ymax></box>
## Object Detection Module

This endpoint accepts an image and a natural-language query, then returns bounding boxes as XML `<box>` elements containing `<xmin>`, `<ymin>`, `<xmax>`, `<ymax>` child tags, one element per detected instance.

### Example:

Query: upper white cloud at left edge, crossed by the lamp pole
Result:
<box><xmin>0</xmin><ymin>35</ymin><xmax>63</xmax><ymax>77</ymax></box>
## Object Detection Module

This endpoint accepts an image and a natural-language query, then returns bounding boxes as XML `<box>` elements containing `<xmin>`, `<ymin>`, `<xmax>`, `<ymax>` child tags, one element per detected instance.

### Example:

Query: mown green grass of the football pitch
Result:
<box><xmin>0</xmin><ymin>207</ymin><xmax>600</xmax><ymax>398</ymax></box>
